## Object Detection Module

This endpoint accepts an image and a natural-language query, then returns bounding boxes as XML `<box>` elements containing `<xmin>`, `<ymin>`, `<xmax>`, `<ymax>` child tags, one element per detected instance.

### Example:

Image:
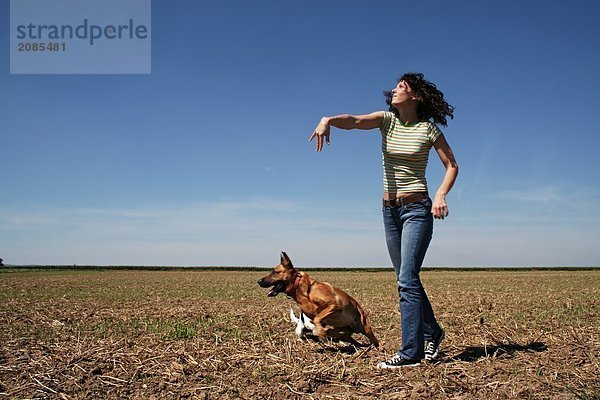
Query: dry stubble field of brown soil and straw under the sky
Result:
<box><xmin>0</xmin><ymin>270</ymin><xmax>600</xmax><ymax>399</ymax></box>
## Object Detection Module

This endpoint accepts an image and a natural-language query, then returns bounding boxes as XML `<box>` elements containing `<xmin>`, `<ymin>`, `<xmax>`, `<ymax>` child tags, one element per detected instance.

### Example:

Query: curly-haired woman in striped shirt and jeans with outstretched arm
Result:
<box><xmin>309</xmin><ymin>73</ymin><xmax>458</xmax><ymax>368</ymax></box>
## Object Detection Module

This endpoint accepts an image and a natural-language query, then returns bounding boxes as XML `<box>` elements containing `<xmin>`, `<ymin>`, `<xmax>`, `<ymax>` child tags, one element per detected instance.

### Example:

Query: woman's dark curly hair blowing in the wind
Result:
<box><xmin>383</xmin><ymin>72</ymin><xmax>454</xmax><ymax>126</ymax></box>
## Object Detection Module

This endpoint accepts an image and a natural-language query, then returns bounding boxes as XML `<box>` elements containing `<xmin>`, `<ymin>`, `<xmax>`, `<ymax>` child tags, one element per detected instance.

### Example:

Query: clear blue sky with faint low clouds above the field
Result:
<box><xmin>0</xmin><ymin>0</ymin><xmax>600</xmax><ymax>266</ymax></box>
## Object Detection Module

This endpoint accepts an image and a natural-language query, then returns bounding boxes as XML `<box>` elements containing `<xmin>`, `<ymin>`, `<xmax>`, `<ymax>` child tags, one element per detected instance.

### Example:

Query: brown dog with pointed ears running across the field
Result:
<box><xmin>258</xmin><ymin>252</ymin><xmax>379</xmax><ymax>346</ymax></box>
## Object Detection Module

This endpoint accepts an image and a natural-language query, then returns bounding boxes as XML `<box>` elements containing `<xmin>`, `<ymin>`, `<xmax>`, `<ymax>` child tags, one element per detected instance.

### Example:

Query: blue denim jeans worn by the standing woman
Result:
<box><xmin>383</xmin><ymin>198</ymin><xmax>442</xmax><ymax>360</ymax></box>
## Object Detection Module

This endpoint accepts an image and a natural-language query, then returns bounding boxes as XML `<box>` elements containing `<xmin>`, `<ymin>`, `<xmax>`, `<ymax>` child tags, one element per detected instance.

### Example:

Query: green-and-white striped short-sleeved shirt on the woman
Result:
<box><xmin>379</xmin><ymin>111</ymin><xmax>442</xmax><ymax>193</ymax></box>
